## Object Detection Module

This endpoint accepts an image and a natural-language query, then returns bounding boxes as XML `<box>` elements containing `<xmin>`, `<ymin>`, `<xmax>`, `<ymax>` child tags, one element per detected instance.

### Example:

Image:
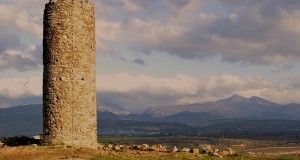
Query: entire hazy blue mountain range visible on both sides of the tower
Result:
<box><xmin>0</xmin><ymin>95</ymin><xmax>300</xmax><ymax>137</ymax></box>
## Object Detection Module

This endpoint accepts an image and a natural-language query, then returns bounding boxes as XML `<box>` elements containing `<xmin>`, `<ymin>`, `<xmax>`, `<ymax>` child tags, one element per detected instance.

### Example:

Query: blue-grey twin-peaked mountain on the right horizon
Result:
<box><xmin>143</xmin><ymin>95</ymin><xmax>300</xmax><ymax>120</ymax></box>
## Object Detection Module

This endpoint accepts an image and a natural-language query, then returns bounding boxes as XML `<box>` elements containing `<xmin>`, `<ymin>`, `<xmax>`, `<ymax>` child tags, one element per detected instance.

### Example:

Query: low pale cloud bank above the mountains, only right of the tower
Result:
<box><xmin>97</xmin><ymin>73</ymin><xmax>300</xmax><ymax>110</ymax></box>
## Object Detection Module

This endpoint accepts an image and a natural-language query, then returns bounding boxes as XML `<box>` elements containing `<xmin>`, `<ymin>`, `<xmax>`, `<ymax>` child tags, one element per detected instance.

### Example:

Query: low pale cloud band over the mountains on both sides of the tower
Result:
<box><xmin>0</xmin><ymin>73</ymin><xmax>300</xmax><ymax>112</ymax></box>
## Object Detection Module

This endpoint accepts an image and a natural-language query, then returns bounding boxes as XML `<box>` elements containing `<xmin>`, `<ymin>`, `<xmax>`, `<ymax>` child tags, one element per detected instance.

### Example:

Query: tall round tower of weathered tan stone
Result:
<box><xmin>43</xmin><ymin>0</ymin><xmax>97</xmax><ymax>148</ymax></box>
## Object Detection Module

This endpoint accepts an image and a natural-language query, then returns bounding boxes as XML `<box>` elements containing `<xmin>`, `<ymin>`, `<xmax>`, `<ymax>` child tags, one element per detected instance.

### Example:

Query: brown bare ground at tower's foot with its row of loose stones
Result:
<box><xmin>0</xmin><ymin>137</ymin><xmax>235</xmax><ymax>160</ymax></box>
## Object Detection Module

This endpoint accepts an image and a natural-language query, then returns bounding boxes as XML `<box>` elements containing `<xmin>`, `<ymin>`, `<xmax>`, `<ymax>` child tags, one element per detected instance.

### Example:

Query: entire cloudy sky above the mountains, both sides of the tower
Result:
<box><xmin>0</xmin><ymin>0</ymin><xmax>300</xmax><ymax>112</ymax></box>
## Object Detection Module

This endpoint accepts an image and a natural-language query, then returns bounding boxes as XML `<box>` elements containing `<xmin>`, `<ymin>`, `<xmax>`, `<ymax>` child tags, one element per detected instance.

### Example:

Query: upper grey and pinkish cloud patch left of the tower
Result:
<box><xmin>0</xmin><ymin>1</ymin><xmax>42</xmax><ymax>72</ymax></box>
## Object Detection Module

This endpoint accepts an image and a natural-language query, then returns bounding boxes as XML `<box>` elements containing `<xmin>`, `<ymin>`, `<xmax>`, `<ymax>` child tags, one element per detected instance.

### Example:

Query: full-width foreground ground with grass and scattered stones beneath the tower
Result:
<box><xmin>0</xmin><ymin>137</ymin><xmax>300</xmax><ymax>160</ymax></box>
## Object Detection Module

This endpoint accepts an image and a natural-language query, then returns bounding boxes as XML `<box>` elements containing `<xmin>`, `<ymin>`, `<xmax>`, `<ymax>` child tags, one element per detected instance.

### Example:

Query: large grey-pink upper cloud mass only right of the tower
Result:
<box><xmin>97</xmin><ymin>0</ymin><xmax>300</xmax><ymax>65</ymax></box>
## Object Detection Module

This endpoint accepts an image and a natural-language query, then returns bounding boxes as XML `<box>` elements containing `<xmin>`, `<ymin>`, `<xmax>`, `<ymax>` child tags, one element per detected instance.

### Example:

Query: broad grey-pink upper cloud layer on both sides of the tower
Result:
<box><xmin>0</xmin><ymin>0</ymin><xmax>300</xmax><ymax>73</ymax></box>
